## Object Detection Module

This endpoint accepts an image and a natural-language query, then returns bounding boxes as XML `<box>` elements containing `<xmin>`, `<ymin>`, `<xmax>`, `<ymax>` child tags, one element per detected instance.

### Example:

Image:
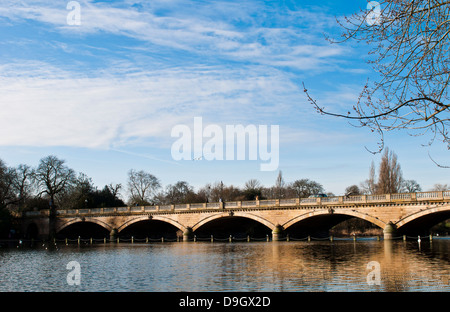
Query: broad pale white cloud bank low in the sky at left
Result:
<box><xmin>0</xmin><ymin>63</ymin><xmax>302</xmax><ymax>147</ymax></box>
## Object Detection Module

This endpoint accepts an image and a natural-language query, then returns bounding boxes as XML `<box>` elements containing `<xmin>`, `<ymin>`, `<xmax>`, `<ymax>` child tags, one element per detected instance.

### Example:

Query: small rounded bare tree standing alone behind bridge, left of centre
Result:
<box><xmin>128</xmin><ymin>169</ymin><xmax>161</xmax><ymax>205</ymax></box>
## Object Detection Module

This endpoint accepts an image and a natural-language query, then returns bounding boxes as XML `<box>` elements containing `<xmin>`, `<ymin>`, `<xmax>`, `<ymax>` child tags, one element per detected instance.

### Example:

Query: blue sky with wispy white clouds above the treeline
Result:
<box><xmin>0</xmin><ymin>0</ymin><xmax>450</xmax><ymax>199</ymax></box>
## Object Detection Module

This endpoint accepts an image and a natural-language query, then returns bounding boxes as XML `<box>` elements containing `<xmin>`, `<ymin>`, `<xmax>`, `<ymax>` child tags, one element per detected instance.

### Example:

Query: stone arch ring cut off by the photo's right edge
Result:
<box><xmin>395</xmin><ymin>203</ymin><xmax>450</xmax><ymax>232</ymax></box>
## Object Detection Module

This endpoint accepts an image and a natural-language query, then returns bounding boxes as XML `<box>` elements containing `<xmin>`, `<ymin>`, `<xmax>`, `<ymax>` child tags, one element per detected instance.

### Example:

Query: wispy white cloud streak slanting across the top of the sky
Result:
<box><xmin>0</xmin><ymin>1</ymin><xmax>344</xmax><ymax>70</ymax></box>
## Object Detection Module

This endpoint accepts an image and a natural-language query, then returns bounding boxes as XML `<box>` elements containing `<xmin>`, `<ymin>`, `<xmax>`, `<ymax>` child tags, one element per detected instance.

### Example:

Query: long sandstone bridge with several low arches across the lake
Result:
<box><xmin>22</xmin><ymin>191</ymin><xmax>450</xmax><ymax>240</ymax></box>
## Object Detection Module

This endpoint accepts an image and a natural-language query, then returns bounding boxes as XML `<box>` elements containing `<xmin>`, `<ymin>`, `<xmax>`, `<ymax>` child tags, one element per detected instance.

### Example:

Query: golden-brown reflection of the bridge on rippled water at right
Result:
<box><xmin>260</xmin><ymin>237</ymin><xmax>450</xmax><ymax>291</ymax></box>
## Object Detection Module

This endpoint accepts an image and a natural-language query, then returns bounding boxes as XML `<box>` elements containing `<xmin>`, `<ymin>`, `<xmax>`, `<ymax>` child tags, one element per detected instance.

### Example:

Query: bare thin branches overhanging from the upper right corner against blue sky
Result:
<box><xmin>303</xmin><ymin>0</ymin><xmax>450</xmax><ymax>155</ymax></box>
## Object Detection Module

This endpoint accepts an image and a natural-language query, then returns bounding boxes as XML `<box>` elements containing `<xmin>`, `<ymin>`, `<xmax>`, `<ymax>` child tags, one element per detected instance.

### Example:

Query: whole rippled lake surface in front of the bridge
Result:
<box><xmin>0</xmin><ymin>240</ymin><xmax>450</xmax><ymax>291</ymax></box>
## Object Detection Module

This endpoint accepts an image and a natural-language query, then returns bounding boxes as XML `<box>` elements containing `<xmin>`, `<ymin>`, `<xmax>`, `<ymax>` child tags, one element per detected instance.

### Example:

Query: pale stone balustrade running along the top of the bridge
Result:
<box><xmin>25</xmin><ymin>191</ymin><xmax>450</xmax><ymax>217</ymax></box>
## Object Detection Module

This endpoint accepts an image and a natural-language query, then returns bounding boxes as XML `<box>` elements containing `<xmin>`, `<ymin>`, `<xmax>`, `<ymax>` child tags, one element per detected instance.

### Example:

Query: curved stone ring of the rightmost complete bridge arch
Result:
<box><xmin>281</xmin><ymin>209</ymin><xmax>386</xmax><ymax>230</ymax></box>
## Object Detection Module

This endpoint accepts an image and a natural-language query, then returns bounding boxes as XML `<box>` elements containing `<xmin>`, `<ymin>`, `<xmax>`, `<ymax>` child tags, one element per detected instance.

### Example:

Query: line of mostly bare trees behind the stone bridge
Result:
<box><xmin>0</xmin><ymin>148</ymin><xmax>448</xmax><ymax>236</ymax></box>
